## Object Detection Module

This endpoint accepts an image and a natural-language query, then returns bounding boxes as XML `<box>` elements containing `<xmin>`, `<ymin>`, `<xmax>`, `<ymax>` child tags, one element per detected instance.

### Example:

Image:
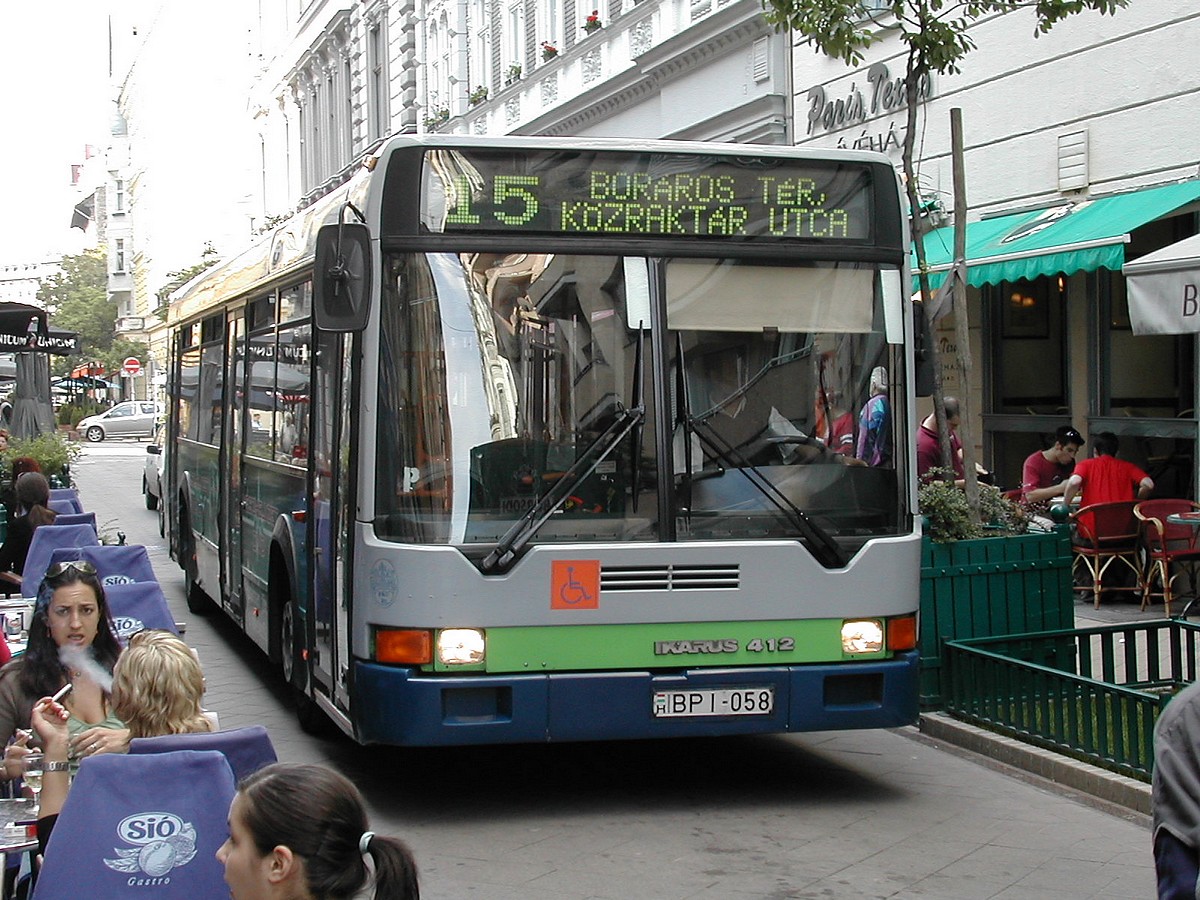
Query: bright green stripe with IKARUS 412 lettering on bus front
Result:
<box><xmin>453</xmin><ymin>618</ymin><xmax>889</xmax><ymax>672</ymax></box>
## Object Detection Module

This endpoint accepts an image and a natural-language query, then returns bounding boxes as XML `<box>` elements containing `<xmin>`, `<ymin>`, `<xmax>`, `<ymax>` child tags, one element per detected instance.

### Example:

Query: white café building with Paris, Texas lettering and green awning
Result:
<box><xmin>792</xmin><ymin>0</ymin><xmax>1200</xmax><ymax>496</ymax></box>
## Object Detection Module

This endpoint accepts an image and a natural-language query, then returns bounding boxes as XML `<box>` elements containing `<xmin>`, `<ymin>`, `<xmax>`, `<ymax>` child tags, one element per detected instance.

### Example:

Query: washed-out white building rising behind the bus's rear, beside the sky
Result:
<box><xmin>104</xmin><ymin>0</ymin><xmax>262</xmax><ymax>397</ymax></box>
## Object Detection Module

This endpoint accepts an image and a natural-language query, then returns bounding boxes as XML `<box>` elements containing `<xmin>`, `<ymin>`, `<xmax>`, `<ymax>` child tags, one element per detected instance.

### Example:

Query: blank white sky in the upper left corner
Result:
<box><xmin>0</xmin><ymin>0</ymin><xmax>113</xmax><ymax>265</ymax></box>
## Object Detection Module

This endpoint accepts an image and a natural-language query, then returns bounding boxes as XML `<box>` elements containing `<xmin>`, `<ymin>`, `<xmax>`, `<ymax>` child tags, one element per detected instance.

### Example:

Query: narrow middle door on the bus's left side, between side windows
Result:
<box><xmin>221</xmin><ymin>316</ymin><xmax>246</xmax><ymax>623</ymax></box>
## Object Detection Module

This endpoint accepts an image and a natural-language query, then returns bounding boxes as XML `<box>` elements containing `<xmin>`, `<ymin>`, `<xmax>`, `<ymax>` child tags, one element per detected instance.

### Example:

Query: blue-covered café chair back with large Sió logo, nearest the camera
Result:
<box><xmin>34</xmin><ymin>750</ymin><xmax>235</xmax><ymax>900</ymax></box>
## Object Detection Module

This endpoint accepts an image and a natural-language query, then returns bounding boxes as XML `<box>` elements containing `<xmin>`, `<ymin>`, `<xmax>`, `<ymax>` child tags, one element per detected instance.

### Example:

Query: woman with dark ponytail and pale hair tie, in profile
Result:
<box><xmin>217</xmin><ymin>763</ymin><xmax>421</xmax><ymax>900</ymax></box>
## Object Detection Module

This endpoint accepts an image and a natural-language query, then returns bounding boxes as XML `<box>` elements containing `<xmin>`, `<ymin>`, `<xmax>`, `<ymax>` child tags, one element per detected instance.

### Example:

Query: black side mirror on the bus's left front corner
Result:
<box><xmin>313</xmin><ymin>222</ymin><xmax>371</xmax><ymax>331</ymax></box>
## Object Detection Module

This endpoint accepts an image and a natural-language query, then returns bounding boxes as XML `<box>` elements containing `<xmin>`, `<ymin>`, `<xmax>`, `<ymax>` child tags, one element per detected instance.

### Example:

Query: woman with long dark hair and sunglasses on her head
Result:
<box><xmin>0</xmin><ymin>560</ymin><xmax>130</xmax><ymax>779</ymax></box>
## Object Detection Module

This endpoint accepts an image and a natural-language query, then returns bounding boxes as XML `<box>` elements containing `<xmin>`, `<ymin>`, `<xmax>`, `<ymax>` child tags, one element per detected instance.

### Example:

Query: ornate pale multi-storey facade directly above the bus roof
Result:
<box><xmin>241</xmin><ymin>0</ymin><xmax>791</xmax><ymax>222</ymax></box>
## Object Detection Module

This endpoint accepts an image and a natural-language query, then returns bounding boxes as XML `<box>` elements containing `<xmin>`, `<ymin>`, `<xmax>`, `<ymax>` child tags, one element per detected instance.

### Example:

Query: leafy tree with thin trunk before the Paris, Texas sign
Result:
<box><xmin>763</xmin><ymin>0</ymin><xmax>1129</xmax><ymax>522</ymax></box>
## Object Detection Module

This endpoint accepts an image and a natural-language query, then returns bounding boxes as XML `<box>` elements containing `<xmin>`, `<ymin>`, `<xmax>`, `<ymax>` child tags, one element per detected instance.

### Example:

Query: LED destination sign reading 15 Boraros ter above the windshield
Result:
<box><xmin>421</xmin><ymin>149</ymin><xmax>872</xmax><ymax>240</ymax></box>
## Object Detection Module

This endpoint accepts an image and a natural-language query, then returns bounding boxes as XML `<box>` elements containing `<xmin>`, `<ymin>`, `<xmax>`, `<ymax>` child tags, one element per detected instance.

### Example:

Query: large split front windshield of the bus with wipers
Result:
<box><xmin>374</xmin><ymin>252</ymin><xmax>910</xmax><ymax>552</ymax></box>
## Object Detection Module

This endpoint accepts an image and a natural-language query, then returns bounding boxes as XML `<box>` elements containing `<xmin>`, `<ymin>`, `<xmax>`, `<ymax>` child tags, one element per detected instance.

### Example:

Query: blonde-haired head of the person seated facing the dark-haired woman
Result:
<box><xmin>113</xmin><ymin>631</ymin><xmax>212</xmax><ymax>738</ymax></box>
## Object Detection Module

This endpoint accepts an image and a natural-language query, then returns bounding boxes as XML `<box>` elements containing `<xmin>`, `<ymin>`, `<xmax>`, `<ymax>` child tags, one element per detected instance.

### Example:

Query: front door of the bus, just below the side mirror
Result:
<box><xmin>308</xmin><ymin>332</ymin><xmax>354</xmax><ymax>709</ymax></box>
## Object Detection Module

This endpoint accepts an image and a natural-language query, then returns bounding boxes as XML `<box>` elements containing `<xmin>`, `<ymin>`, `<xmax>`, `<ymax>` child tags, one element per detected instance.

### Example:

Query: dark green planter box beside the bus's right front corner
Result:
<box><xmin>920</xmin><ymin>527</ymin><xmax>1075</xmax><ymax>709</ymax></box>
